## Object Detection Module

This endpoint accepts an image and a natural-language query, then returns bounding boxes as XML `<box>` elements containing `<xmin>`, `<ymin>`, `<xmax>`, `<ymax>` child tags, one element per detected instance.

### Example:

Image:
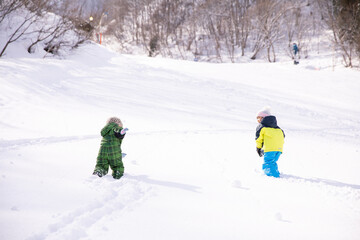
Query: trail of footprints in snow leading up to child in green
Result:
<box><xmin>28</xmin><ymin>175</ymin><xmax>151</xmax><ymax>240</ymax></box>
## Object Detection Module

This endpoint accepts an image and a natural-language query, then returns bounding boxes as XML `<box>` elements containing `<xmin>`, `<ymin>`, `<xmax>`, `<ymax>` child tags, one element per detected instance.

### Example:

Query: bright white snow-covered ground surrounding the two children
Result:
<box><xmin>0</xmin><ymin>44</ymin><xmax>360</xmax><ymax>240</ymax></box>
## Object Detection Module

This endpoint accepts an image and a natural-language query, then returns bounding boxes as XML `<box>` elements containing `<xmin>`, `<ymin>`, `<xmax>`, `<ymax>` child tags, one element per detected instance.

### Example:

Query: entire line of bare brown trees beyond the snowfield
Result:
<box><xmin>0</xmin><ymin>0</ymin><xmax>360</xmax><ymax>67</ymax></box>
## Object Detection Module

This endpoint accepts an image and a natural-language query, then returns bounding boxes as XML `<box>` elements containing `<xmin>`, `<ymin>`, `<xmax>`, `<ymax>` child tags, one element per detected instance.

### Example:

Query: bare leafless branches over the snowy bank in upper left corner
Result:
<box><xmin>0</xmin><ymin>0</ymin><xmax>95</xmax><ymax>57</ymax></box>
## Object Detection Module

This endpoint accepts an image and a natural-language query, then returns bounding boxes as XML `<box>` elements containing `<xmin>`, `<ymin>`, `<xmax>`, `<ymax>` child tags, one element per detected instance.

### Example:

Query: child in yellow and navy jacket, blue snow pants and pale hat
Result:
<box><xmin>255</xmin><ymin>107</ymin><xmax>285</xmax><ymax>178</ymax></box>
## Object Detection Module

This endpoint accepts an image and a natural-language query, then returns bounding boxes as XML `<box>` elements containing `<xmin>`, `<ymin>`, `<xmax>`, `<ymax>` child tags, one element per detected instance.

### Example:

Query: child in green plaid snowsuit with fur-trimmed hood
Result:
<box><xmin>93</xmin><ymin>117</ymin><xmax>125</xmax><ymax>179</ymax></box>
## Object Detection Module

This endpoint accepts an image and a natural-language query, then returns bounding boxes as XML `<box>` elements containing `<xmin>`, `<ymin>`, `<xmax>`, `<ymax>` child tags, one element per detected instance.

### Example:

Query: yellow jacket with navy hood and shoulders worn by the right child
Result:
<box><xmin>255</xmin><ymin>116</ymin><xmax>285</xmax><ymax>152</ymax></box>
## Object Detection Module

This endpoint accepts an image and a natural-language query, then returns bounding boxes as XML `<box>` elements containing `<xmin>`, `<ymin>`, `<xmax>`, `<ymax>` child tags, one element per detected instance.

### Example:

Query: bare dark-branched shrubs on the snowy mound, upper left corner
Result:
<box><xmin>0</xmin><ymin>0</ymin><xmax>91</xmax><ymax>57</ymax></box>
